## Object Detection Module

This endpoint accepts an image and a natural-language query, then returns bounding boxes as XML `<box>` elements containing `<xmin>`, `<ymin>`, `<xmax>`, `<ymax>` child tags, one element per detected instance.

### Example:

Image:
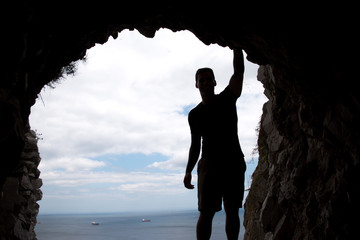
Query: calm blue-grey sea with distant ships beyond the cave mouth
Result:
<box><xmin>35</xmin><ymin>209</ymin><xmax>245</xmax><ymax>240</ymax></box>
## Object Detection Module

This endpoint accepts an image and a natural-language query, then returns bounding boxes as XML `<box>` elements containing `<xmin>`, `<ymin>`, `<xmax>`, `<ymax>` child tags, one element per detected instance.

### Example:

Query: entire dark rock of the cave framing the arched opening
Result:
<box><xmin>0</xmin><ymin>0</ymin><xmax>360</xmax><ymax>239</ymax></box>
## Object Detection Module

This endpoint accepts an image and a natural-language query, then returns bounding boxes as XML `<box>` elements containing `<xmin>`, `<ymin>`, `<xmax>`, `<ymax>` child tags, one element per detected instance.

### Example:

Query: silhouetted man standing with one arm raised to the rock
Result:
<box><xmin>184</xmin><ymin>49</ymin><xmax>246</xmax><ymax>240</ymax></box>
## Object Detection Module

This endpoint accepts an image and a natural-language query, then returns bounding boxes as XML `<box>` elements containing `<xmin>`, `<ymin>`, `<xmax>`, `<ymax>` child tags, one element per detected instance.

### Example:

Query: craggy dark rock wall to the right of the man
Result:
<box><xmin>244</xmin><ymin>65</ymin><xmax>360</xmax><ymax>240</ymax></box>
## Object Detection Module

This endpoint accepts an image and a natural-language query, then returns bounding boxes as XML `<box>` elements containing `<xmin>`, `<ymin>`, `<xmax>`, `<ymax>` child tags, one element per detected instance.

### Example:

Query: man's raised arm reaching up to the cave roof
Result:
<box><xmin>229</xmin><ymin>49</ymin><xmax>245</xmax><ymax>97</ymax></box>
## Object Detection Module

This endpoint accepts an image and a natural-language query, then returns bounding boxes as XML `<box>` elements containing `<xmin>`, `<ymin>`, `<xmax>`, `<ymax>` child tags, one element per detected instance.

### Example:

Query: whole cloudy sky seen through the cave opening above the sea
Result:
<box><xmin>30</xmin><ymin>29</ymin><xmax>267</xmax><ymax>214</ymax></box>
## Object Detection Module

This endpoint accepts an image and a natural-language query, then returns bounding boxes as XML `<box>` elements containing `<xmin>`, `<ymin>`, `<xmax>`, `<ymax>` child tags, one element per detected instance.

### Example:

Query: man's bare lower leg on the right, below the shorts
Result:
<box><xmin>224</xmin><ymin>202</ymin><xmax>240</xmax><ymax>240</ymax></box>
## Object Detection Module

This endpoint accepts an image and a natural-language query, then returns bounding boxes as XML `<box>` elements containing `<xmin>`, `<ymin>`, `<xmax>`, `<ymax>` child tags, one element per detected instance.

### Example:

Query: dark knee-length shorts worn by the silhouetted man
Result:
<box><xmin>198</xmin><ymin>159</ymin><xmax>246</xmax><ymax>212</ymax></box>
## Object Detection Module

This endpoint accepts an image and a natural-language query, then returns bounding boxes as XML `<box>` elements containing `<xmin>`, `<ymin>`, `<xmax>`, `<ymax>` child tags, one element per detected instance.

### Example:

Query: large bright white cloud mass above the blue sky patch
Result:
<box><xmin>31</xmin><ymin>31</ymin><xmax>259</xmax><ymax>163</ymax></box>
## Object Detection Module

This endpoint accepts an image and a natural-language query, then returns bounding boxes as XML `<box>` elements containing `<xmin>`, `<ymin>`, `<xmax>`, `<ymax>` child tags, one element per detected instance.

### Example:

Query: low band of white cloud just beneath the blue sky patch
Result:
<box><xmin>42</xmin><ymin>167</ymin><xmax>190</xmax><ymax>195</ymax></box>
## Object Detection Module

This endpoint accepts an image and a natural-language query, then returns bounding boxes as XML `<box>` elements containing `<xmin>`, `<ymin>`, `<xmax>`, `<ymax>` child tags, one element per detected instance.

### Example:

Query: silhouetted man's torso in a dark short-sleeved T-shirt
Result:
<box><xmin>189</xmin><ymin>88</ymin><xmax>244</xmax><ymax>170</ymax></box>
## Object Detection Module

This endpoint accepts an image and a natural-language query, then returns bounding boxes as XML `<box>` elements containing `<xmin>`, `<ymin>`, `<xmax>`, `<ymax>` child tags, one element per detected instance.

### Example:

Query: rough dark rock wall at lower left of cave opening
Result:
<box><xmin>0</xmin><ymin>130</ymin><xmax>42</xmax><ymax>240</ymax></box>
